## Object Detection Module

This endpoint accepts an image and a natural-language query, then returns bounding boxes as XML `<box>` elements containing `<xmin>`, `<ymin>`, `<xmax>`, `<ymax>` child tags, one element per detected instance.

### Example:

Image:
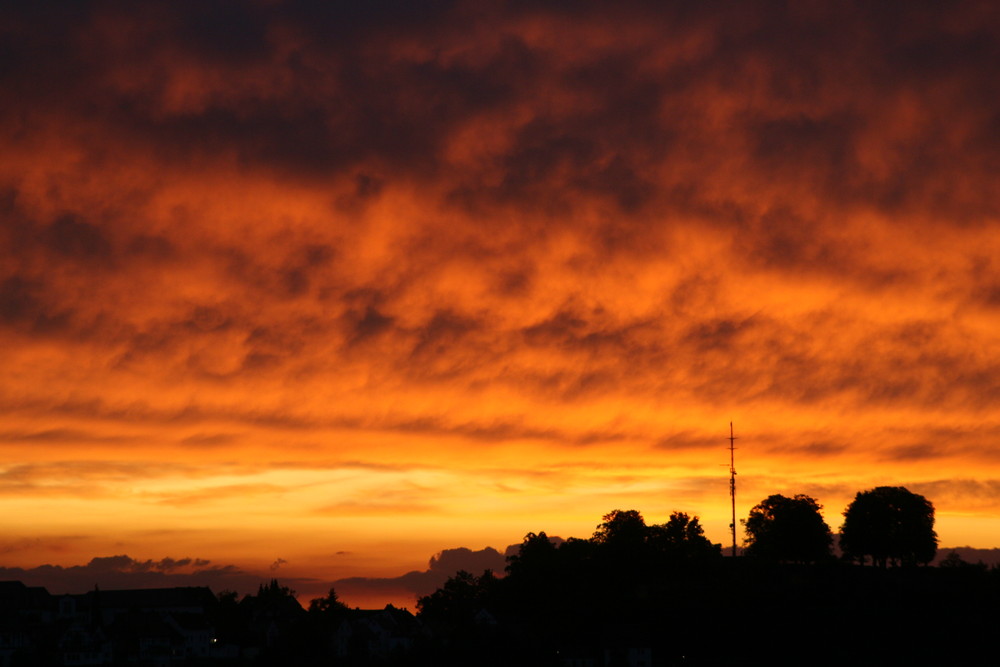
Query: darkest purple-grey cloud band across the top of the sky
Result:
<box><xmin>8</xmin><ymin>2</ymin><xmax>998</xmax><ymax>222</ymax></box>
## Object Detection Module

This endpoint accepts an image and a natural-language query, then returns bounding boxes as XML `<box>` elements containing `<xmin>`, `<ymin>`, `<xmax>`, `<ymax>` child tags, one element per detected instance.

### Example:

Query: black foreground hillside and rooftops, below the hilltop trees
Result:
<box><xmin>0</xmin><ymin>560</ymin><xmax>1000</xmax><ymax>667</ymax></box>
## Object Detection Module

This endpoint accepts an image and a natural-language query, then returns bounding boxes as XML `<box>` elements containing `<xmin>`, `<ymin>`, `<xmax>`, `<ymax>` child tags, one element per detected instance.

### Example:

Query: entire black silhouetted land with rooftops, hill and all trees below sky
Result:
<box><xmin>0</xmin><ymin>487</ymin><xmax>1000</xmax><ymax>667</ymax></box>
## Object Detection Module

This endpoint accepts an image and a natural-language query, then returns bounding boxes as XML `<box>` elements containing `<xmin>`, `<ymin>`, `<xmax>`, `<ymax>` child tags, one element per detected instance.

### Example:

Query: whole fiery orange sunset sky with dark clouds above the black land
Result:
<box><xmin>0</xmin><ymin>0</ymin><xmax>1000</xmax><ymax>602</ymax></box>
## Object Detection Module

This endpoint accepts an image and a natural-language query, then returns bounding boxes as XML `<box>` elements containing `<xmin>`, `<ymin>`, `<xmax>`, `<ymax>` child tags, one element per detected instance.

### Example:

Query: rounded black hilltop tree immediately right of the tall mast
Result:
<box><xmin>743</xmin><ymin>494</ymin><xmax>833</xmax><ymax>563</ymax></box>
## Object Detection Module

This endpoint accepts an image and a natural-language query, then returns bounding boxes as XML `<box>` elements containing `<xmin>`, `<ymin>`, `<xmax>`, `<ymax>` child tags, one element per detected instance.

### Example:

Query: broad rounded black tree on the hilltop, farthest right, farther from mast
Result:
<box><xmin>840</xmin><ymin>486</ymin><xmax>937</xmax><ymax>567</ymax></box>
